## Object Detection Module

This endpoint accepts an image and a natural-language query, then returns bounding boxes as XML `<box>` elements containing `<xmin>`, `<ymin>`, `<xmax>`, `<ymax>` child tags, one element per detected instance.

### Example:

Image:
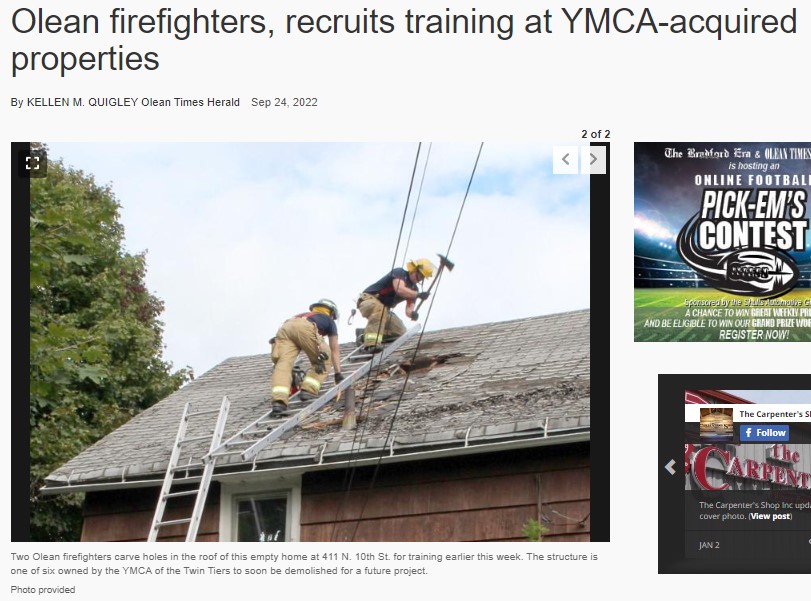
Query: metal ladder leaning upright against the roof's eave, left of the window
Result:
<box><xmin>147</xmin><ymin>396</ymin><xmax>231</xmax><ymax>542</ymax></box>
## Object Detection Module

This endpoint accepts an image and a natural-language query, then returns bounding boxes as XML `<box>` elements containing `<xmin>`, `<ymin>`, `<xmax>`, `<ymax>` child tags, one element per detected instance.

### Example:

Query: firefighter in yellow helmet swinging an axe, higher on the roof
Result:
<box><xmin>358</xmin><ymin>259</ymin><xmax>436</xmax><ymax>352</ymax></box>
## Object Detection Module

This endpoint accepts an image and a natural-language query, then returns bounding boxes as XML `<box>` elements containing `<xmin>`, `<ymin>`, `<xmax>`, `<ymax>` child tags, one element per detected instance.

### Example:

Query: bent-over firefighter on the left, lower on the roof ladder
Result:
<box><xmin>270</xmin><ymin>298</ymin><xmax>344</xmax><ymax>415</ymax></box>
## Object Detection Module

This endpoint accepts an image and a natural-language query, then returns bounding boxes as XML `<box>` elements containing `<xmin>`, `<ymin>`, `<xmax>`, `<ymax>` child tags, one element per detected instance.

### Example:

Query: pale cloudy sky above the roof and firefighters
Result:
<box><xmin>46</xmin><ymin>142</ymin><xmax>589</xmax><ymax>376</ymax></box>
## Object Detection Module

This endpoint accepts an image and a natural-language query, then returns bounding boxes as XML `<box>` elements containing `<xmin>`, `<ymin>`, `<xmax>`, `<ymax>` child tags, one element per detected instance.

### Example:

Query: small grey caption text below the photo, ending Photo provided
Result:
<box><xmin>9</xmin><ymin>551</ymin><xmax>598</xmax><ymax>595</ymax></box>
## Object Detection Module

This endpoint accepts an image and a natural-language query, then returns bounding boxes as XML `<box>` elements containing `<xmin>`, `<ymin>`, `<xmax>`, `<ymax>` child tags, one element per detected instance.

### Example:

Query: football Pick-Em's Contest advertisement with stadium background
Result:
<box><xmin>634</xmin><ymin>142</ymin><xmax>811</xmax><ymax>342</ymax></box>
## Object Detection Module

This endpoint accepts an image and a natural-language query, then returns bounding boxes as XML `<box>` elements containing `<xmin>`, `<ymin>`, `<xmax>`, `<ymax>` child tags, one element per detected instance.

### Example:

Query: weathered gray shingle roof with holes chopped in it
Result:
<box><xmin>46</xmin><ymin>310</ymin><xmax>590</xmax><ymax>488</ymax></box>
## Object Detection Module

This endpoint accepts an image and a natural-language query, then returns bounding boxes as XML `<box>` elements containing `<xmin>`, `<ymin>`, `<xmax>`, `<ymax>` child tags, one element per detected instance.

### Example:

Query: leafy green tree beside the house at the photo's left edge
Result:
<box><xmin>29</xmin><ymin>149</ymin><xmax>190</xmax><ymax>541</ymax></box>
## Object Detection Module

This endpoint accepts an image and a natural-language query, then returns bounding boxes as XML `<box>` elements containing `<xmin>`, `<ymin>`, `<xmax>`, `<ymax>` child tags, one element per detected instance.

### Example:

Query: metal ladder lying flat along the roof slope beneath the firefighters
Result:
<box><xmin>203</xmin><ymin>324</ymin><xmax>420</xmax><ymax>463</ymax></box>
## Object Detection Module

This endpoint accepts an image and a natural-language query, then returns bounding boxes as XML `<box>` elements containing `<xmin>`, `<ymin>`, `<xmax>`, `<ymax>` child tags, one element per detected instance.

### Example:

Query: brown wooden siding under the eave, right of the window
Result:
<box><xmin>301</xmin><ymin>445</ymin><xmax>590</xmax><ymax>542</ymax></box>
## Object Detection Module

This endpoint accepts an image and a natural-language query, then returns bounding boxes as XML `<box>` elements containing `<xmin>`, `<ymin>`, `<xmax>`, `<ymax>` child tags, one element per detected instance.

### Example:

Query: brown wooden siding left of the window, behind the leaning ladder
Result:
<box><xmin>82</xmin><ymin>482</ymin><xmax>220</xmax><ymax>542</ymax></box>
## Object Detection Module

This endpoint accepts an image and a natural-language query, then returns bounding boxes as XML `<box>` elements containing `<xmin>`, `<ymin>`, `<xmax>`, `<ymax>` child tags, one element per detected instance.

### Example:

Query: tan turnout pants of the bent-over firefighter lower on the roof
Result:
<box><xmin>270</xmin><ymin>317</ymin><xmax>329</xmax><ymax>405</ymax></box>
